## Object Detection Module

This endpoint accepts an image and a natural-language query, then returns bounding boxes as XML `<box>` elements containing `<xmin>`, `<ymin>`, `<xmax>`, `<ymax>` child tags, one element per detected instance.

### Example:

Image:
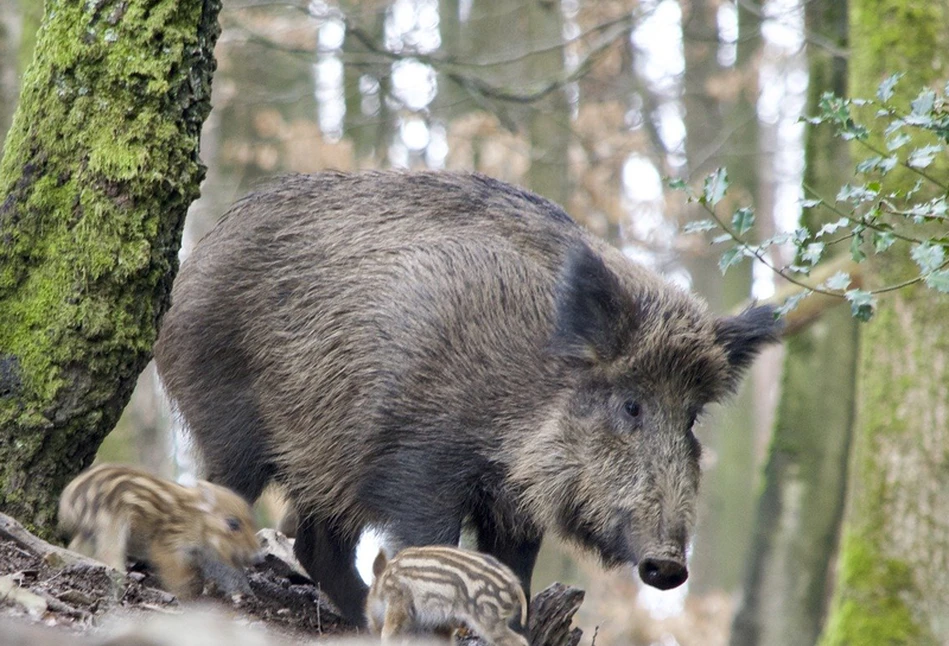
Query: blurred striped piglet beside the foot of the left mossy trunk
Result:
<box><xmin>59</xmin><ymin>464</ymin><xmax>260</xmax><ymax>598</ymax></box>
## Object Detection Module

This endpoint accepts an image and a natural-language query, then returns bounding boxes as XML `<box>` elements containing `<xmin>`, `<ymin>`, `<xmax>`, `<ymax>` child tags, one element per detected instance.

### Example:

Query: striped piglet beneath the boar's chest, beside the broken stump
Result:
<box><xmin>366</xmin><ymin>545</ymin><xmax>527</xmax><ymax>646</ymax></box>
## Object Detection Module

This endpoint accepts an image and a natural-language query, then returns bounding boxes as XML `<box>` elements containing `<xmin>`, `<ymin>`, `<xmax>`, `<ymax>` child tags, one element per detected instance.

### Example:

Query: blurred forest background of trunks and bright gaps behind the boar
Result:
<box><xmin>0</xmin><ymin>0</ymin><xmax>949</xmax><ymax>646</ymax></box>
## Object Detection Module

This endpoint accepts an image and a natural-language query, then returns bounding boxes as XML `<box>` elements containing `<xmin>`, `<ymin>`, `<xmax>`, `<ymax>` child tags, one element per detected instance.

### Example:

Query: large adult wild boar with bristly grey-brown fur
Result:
<box><xmin>155</xmin><ymin>172</ymin><xmax>779</xmax><ymax>623</ymax></box>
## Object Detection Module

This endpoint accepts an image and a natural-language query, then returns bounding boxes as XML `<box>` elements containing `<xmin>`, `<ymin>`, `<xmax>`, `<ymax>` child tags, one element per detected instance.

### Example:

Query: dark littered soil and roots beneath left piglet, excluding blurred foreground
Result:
<box><xmin>0</xmin><ymin>515</ymin><xmax>356</xmax><ymax>646</ymax></box>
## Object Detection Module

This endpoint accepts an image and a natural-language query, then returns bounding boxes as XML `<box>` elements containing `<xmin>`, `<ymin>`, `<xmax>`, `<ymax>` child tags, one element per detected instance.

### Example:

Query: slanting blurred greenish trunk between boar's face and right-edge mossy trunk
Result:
<box><xmin>731</xmin><ymin>0</ymin><xmax>857</xmax><ymax>646</ymax></box>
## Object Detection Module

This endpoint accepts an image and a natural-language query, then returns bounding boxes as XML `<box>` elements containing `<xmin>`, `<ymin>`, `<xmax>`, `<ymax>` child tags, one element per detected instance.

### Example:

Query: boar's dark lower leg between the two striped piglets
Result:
<box><xmin>293</xmin><ymin>514</ymin><xmax>368</xmax><ymax>627</ymax></box>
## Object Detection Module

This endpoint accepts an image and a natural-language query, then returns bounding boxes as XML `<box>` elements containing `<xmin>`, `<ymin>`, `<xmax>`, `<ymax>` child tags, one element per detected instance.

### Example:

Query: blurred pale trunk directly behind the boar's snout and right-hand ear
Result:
<box><xmin>680</xmin><ymin>0</ymin><xmax>770</xmax><ymax>593</ymax></box>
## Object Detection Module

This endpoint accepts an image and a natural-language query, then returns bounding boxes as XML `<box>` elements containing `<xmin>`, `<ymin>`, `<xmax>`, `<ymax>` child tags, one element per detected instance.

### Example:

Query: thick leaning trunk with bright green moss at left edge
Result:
<box><xmin>0</xmin><ymin>0</ymin><xmax>220</xmax><ymax>534</ymax></box>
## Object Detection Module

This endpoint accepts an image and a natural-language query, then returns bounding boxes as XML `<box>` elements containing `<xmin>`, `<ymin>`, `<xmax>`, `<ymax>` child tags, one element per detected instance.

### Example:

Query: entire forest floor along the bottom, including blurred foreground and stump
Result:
<box><xmin>0</xmin><ymin>514</ymin><xmax>583</xmax><ymax>646</ymax></box>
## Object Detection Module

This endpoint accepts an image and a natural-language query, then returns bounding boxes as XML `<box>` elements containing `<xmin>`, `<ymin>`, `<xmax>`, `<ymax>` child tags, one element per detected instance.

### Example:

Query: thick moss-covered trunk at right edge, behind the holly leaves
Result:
<box><xmin>821</xmin><ymin>0</ymin><xmax>949</xmax><ymax>646</ymax></box>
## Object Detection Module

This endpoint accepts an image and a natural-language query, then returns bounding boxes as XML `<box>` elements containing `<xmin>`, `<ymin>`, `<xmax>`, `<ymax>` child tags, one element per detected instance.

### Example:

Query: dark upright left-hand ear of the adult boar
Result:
<box><xmin>552</xmin><ymin>245</ymin><xmax>634</xmax><ymax>361</ymax></box>
